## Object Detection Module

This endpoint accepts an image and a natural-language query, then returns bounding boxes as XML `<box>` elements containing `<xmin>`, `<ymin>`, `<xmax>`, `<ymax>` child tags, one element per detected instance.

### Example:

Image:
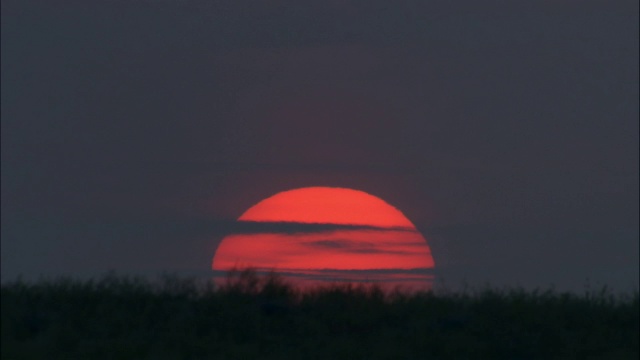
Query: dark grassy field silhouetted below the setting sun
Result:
<box><xmin>1</xmin><ymin>272</ymin><xmax>639</xmax><ymax>359</ymax></box>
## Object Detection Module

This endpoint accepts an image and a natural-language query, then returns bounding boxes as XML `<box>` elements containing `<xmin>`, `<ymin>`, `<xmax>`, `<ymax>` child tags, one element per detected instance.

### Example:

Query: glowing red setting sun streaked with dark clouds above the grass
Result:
<box><xmin>212</xmin><ymin>187</ymin><xmax>434</xmax><ymax>288</ymax></box>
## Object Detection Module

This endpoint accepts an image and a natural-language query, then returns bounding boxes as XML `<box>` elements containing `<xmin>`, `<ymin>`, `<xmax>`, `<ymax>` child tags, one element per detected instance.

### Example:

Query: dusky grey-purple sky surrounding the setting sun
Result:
<box><xmin>0</xmin><ymin>0</ymin><xmax>640</xmax><ymax>291</ymax></box>
